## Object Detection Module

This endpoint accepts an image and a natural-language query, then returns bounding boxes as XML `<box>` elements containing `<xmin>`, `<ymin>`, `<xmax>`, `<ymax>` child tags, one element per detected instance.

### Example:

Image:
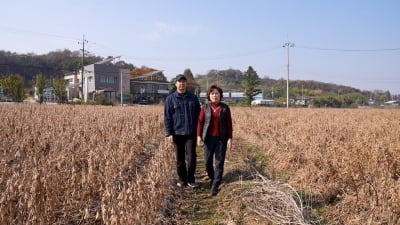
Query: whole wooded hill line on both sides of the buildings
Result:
<box><xmin>0</xmin><ymin>50</ymin><xmax>399</xmax><ymax>107</ymax></box>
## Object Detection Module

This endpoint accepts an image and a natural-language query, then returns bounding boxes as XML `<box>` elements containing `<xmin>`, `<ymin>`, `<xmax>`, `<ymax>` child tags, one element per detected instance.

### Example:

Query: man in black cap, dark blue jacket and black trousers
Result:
<box><xmin>164</xmin><ymin>74</ymin><xmax>200</xmax><ymax>188</ymax></box>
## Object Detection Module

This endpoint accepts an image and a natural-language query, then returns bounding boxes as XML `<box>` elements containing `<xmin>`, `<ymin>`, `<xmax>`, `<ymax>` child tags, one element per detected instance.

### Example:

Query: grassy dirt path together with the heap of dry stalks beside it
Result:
<box><xmin>162</xmin><ymin>138</ymin><xmax>320</xmax><ymax>225</ymax></box>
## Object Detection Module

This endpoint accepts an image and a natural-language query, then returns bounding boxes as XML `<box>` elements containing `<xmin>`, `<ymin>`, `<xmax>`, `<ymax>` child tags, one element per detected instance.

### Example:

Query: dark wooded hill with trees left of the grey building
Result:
<box><xmin>0</xmin><ymin>49</ymin><xmax>135</xmax><ymax>103</ymax></box>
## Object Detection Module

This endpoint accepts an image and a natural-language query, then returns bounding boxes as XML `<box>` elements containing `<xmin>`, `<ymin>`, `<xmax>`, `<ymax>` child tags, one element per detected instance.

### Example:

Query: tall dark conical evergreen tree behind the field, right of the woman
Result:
<box><xmin>242</xmin><ymin>66</ymin><xmax>261</xmax><ymax>106</ymax></box>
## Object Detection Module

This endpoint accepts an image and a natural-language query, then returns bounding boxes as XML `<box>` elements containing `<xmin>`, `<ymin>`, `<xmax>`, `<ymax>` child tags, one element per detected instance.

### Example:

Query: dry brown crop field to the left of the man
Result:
<box><xmin>0</xmin><ymin>104</ymin><xmax>173</xmax><ymax>224</ymax></box>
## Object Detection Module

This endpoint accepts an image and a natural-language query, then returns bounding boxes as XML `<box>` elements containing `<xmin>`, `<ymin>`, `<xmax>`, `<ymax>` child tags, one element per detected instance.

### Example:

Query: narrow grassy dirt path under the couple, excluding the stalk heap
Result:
<box><xmin>164</xmin><ymin>140</ymin><xmax>271</xmax><ymax>225</ymax></box>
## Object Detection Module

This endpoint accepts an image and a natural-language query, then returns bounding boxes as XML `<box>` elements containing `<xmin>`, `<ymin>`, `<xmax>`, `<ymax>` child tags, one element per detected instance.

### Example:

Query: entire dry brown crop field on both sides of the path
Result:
<box><xmin>0</xmin><ymin>104</ymin><xmax>400</xmax><ymax>225</ymax></box>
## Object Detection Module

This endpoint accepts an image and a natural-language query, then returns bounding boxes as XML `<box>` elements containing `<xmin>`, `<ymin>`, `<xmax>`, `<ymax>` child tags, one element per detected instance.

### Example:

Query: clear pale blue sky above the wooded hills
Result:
<box><xmin>0</xmin><ymin>0</ymin><xmax>400</xmax><ymax>94</ymax></box>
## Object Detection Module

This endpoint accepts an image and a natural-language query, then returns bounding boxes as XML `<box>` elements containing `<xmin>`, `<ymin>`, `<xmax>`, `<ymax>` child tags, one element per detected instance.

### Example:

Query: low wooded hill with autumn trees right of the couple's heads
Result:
<box><xmin>196</xmin><ymin>67</ymin><xmax>400</xmax><ymax>107</ymax></box>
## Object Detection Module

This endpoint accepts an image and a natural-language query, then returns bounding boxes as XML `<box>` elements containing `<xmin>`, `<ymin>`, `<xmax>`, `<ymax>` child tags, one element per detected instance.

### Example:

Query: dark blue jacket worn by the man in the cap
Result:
<box><xmin>164</xmin><ymin>91</ymin><xmax>200</xmax><ymax>137</ymax></box>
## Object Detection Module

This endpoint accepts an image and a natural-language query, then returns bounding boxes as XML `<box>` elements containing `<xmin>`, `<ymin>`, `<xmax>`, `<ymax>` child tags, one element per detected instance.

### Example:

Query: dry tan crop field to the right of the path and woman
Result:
<box><xmin>232</xmin><ymin>108</ymin><xmax>400</xmax><ymax>224</ymax></box>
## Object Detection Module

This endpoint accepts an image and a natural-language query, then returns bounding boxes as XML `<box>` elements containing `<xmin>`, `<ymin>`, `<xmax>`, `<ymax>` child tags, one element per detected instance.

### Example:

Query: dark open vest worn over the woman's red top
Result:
<box><xmin>201</xmin><ymin>102</ymin><xmax>228</xmax><ymax>141</ymax></box>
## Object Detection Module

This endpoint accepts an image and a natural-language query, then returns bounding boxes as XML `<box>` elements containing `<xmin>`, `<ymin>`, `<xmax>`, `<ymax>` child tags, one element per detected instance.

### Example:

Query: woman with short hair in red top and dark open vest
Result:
<box><xmin>197</xmin><ymin>85</ymin><xmax>232</xmax><ymax>196</ymax></box>
